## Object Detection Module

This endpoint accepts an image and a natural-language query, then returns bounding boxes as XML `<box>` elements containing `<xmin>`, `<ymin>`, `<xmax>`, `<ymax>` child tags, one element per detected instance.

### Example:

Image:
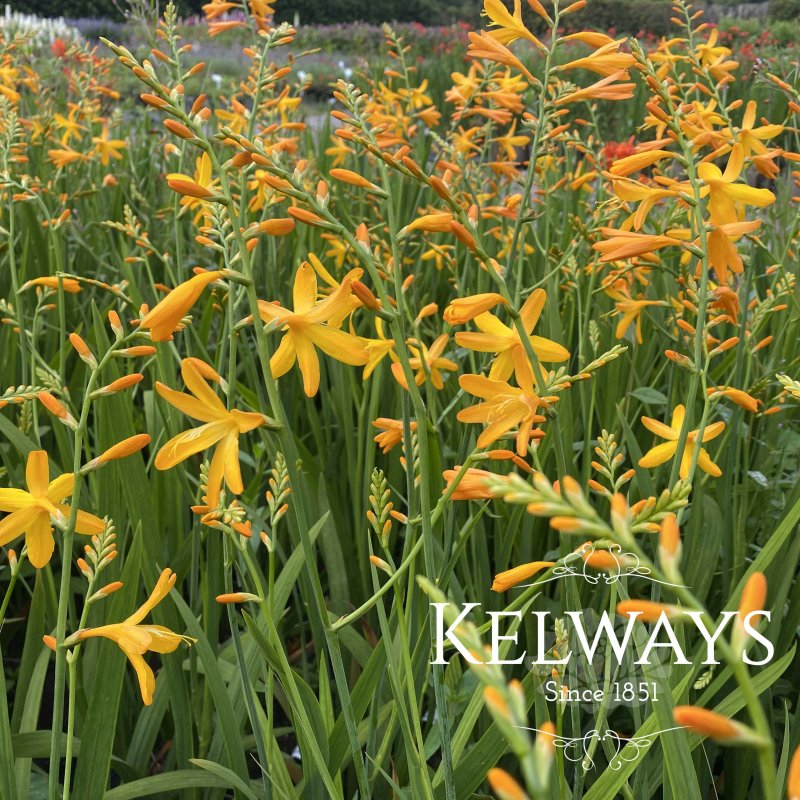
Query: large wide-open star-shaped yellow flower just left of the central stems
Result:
<box><xmin>258</xmin><ymin>262</ymin><xmax>369</xmax><ymax>397</ymax></box>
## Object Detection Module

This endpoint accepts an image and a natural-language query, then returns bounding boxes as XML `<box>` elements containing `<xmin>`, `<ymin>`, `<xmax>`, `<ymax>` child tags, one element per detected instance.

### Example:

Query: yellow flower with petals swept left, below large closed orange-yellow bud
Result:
<box><xmin>155</xmin><ymin>358</ymin><xmax>268</xmax><ymax>504</ymax></box>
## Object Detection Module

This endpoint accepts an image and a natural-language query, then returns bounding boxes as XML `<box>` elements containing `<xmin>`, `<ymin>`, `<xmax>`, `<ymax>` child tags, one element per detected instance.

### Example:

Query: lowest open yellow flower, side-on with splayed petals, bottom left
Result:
<box><xmin>64</xmin><ymin>569</ymin><xmax>197</xmax><ymax>706</ymax></box>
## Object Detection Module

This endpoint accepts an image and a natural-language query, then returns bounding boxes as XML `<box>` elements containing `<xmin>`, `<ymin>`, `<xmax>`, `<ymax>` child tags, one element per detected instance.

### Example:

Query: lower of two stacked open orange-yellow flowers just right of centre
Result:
<box><xmin>456</xmin><ymin>375</ymin><xmax>547</xmax><ymax>456</ymax></box>
